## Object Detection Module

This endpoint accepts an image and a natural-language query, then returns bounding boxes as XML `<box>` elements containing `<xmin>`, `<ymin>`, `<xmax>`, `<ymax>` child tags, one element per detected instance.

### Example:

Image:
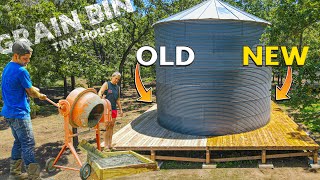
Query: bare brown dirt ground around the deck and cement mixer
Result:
<box><xmin>0</xmin><ymin>88</ymin><xmax>320</xmax><ymax>180</ymax></box>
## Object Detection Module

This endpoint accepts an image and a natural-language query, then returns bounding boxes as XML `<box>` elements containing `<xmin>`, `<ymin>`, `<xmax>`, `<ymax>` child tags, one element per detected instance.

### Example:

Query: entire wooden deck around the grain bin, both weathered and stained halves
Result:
<box><xmin>113</xmin><ymin>102</ymin><xmax>319</xmax><ymax>163</ymax></box>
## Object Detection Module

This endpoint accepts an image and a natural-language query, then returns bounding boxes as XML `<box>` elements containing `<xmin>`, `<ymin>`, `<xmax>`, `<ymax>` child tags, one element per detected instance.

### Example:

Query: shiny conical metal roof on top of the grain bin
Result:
<box><xmin>155</xmin><ymin>0</ymin><xmax>271</xmax><ymax>25</ymax></box>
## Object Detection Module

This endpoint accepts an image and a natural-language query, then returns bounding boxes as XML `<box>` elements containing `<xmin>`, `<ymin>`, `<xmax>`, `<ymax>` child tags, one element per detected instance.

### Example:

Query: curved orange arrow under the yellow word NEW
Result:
<box><xmin>276</xmin><ymin>66</ymin><xmax>292</xmax><ymax>101</ymax></box>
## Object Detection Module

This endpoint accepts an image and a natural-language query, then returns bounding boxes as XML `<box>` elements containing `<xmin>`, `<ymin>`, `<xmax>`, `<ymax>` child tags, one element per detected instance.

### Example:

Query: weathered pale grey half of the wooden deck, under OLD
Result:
<box><xmin>112</xmin><ymin>105</ymin><xmax>207</xmax><ymax>150</ymax></box>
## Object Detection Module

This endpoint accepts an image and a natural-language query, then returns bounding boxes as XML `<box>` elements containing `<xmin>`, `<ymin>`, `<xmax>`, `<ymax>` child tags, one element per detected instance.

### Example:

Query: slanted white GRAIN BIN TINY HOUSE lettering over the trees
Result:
<box><xmin>0</xmin><ymin>0</ymin><xmax>133</xmax><ymax>54</ymax></box>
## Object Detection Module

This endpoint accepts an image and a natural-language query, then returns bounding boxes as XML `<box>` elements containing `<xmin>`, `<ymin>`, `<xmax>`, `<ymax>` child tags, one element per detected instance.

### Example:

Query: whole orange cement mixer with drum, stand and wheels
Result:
<box><xmin>46</xmin><ymin>88</ymin><xmax>111</xmax><ymax>179</ymax></box>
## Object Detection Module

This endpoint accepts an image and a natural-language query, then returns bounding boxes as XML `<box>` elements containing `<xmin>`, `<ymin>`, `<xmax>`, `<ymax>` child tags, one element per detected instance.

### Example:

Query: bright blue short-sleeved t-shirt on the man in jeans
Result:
<box><xmin>1</xmin><ymin>62</ymin><xmax>32</xmax><ymax>119</ymax></box>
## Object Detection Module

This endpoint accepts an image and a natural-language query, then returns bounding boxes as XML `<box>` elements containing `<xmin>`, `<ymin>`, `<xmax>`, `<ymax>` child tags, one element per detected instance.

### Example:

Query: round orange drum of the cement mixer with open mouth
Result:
<box><xmin>66</xmin><ymin>88</ymin><xmax>104</xmax><ymax>128</ymax></box>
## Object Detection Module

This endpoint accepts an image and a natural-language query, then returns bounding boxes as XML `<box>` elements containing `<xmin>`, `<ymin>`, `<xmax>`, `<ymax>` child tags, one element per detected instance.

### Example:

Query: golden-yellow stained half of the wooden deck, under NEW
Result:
<box><xmin>207</xmin><ymin>103</ymin><xmax>319</xmax><ymax>150</ymax></box>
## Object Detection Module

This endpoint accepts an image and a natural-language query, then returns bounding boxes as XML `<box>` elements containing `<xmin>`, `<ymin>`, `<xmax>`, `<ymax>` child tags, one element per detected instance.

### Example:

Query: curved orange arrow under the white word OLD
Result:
<box><xmin>134</xmin><ymin>63</ymin><xmax>152</xmax><ymax>102</ymax></box>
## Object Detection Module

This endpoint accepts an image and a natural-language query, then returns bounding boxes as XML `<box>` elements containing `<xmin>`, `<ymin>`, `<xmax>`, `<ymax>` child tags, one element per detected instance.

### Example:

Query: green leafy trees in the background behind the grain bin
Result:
<box><xmin>0</xmin><ymin>0</ymin><xmax>320</xmax><ymax>129</ymax></box>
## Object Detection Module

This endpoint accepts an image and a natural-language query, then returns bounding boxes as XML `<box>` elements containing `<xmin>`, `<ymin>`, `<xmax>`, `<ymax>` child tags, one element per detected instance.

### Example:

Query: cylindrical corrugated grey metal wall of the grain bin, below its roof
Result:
<box><xmin>155</xmin><ymin>20</ymin><xmax>271</xmax><ymax>136</ymax></box>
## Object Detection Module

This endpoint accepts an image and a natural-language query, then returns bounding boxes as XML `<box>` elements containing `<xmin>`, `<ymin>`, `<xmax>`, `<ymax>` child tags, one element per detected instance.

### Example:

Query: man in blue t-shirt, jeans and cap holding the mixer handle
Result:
<box><xmin>1</xmin><ymin>40</ymin><xmax>46</xmax><ymax>179</ymax></box>
